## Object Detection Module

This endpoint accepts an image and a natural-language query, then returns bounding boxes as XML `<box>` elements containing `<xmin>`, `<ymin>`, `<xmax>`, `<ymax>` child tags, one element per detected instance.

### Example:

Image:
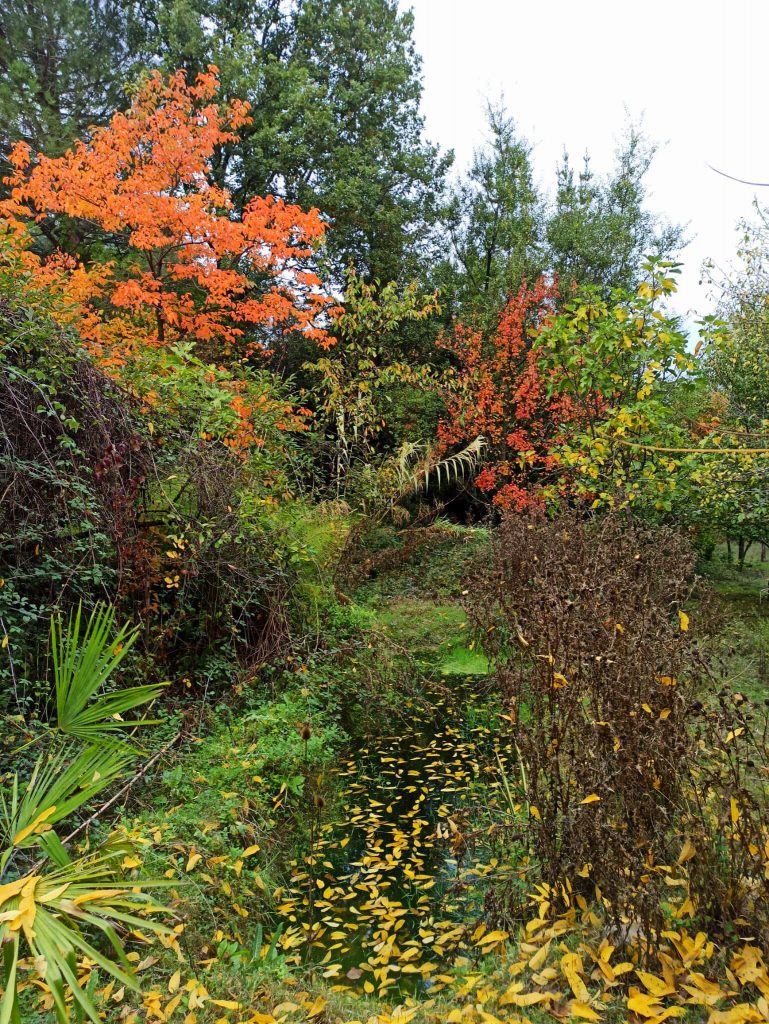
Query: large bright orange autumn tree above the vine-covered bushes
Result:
<box><xmin>0</xmin><ymin>67</ymin><xmax>335</xmax><ymax>374</ymax></box>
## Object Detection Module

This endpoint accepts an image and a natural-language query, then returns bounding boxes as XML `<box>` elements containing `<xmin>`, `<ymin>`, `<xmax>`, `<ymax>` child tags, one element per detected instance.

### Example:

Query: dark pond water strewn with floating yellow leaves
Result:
<box><xmin>270</xmin><ymin>685</ymin><xmax>512</xmax><ymax>995</ymax></box>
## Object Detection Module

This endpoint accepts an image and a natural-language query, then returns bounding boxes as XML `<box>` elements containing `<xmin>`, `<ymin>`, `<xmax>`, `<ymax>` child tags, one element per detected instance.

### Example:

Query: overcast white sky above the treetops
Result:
<box><xmin>401</xmin><ymin>0</ymin><xmax>769</xmax><ymax>323</ymax></box>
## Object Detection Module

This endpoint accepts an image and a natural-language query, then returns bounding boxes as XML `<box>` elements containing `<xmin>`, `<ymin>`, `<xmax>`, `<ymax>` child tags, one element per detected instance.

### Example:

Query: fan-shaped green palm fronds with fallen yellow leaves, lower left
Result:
<box><xmin>0</xmin><ymin>606</ymin><xmax>168</xmax><ymax>1024</ymax></box>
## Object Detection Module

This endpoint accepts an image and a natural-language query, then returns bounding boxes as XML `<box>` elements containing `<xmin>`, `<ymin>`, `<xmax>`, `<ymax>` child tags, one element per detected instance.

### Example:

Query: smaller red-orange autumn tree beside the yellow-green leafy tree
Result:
<box><xmin>438</xmin><ymin>278</ymin><xmax>579</xmax><ymax>511</ymax></box>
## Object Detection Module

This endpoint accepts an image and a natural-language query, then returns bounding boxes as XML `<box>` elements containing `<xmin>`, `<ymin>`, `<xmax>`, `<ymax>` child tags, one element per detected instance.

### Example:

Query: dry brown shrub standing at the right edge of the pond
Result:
<box><xmin>467</xmin><ymin>514</ymin><xmax>704</xmax><ymax>933</ymax></box>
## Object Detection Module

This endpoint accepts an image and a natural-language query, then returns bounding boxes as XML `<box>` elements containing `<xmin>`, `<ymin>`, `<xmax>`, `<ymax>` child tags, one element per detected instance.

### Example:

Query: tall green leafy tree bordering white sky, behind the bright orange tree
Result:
<box><xmin>145</xmin><ymin>0</ymin><xmax>451</xmax><ymax>282</ymax></box>
